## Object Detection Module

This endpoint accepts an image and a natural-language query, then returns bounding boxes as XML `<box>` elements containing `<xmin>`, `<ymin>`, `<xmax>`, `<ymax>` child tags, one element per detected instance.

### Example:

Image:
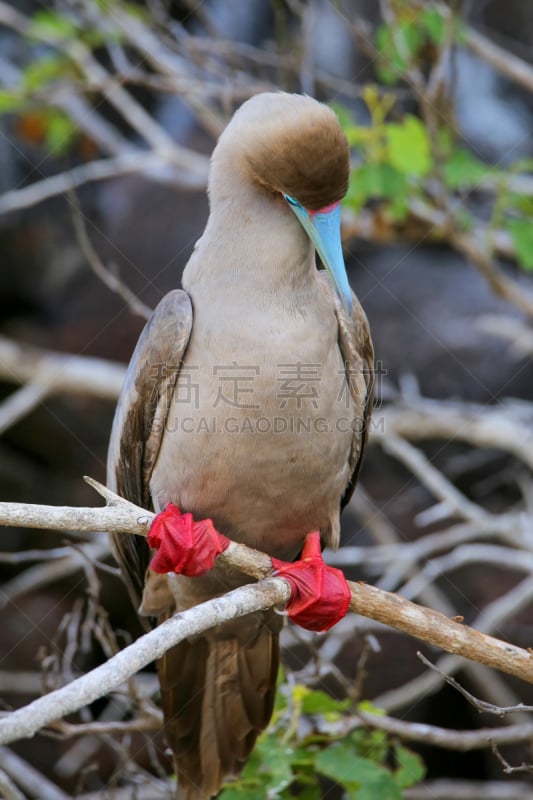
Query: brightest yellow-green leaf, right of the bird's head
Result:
<box><xmin>386</xmin><ymin>114</ymin><xmax>431</xmax><ymax>177</ymax></box>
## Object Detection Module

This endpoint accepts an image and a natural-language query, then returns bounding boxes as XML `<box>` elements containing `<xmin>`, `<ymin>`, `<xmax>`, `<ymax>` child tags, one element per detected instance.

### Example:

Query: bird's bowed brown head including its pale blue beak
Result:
<box><xmin>212</xmin><ymin>92</ymin><xmax>352</xmax><ymax>315</ymax></box>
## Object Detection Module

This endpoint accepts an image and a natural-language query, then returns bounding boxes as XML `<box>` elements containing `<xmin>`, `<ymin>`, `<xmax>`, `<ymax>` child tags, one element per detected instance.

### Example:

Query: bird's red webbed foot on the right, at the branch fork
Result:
<box><xmin>272</xmin><ymin>531</ymin><xmax>351</xmax><ymax>631</ymax></box>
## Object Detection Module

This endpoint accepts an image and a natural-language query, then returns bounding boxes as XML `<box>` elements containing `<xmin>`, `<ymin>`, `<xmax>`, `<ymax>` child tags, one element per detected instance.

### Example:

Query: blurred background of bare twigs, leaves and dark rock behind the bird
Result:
<box><xmin>0</xmin><ymin>0</ymin><xmax>533</xmax><ymax>800</ymax></box>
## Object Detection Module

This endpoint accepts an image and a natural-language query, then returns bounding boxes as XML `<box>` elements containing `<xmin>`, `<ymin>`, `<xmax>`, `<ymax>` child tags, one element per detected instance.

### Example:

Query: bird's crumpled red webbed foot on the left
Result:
<box><xmin>147</xmin><ymin>503</ymin><xmax>230</xmax><ymax>578</ymax></box>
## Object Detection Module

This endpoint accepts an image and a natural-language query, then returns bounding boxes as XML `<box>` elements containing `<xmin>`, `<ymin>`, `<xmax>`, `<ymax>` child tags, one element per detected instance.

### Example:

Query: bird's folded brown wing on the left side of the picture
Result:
<box><xmin>107</xmin><ymin>289</ymin><xmax>193</xmax><ymax>608</ymax></box>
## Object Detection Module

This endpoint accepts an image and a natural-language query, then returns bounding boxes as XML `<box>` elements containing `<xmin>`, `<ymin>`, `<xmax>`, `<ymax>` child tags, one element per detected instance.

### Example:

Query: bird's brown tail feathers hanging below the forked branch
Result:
<box><xmin>158</xmin><ymin>612</ymin><xmax>279</xmax><ymax>800</ymax></box>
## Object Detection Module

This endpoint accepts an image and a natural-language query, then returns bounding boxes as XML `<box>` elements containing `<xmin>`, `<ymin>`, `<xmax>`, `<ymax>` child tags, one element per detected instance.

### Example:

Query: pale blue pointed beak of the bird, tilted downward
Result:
<box><xmin>284</xmin><ymin>194</ymin><xmax>352</xmax><ymax>317</ymax></box>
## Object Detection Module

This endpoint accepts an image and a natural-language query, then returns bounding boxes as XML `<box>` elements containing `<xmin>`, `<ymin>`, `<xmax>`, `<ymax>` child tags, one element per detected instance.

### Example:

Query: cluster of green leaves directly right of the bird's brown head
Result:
<box><xmin>335</xmin><ymin>74</ymin><xmax>533</xmax><ymax>270</ymax></box>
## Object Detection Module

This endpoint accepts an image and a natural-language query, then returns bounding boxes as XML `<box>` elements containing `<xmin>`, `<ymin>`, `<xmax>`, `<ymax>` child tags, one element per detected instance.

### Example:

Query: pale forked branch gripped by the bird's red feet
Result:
<box><xmin>0</xmin><ymin>479</ymin><xmax>533</xmax><ymax>743</ymax></box>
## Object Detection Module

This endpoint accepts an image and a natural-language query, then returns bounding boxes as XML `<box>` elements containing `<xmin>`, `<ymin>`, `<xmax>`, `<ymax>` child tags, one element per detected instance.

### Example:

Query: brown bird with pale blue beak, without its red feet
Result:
<box><xmin>108</xmin><ymin>92</ymin><xmax>373</xmax><ymax>800</ymax></box>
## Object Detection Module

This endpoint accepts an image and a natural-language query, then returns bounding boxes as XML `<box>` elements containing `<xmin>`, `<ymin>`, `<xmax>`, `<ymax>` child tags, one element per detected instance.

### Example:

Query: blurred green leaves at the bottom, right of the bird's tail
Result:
<box><xmin>220</xmin><ymin>684</ymin><xmax>424</xmax><ymax>800</ymax></box>
